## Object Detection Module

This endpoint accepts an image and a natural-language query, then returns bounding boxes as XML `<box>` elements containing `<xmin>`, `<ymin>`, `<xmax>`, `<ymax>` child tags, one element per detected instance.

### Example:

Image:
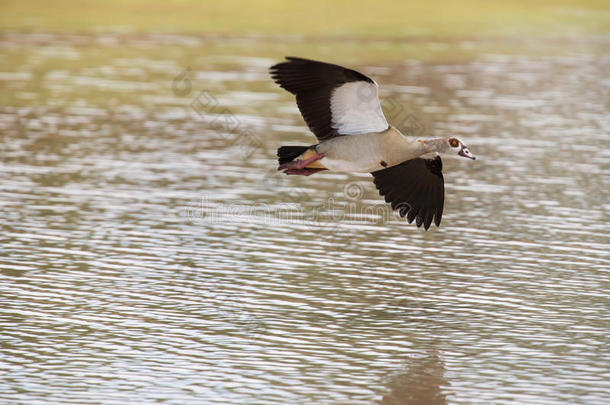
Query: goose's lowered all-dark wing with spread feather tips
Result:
<box><xmin>371</xmin><ymin>156</ymin><xmax>445</xmax><ymax>230</ymax></box>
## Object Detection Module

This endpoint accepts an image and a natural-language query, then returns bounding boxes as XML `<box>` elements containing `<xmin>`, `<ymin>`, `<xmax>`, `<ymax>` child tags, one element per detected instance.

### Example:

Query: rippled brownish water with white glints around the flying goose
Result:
<box><xmin>0</xmin><ymin>35</ymin><xmax>610</xmax><ymax>404</ymax></box>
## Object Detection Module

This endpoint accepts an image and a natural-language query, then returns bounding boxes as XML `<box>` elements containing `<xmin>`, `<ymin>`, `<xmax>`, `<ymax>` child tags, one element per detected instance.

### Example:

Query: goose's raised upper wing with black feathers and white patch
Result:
<box><xmin>270</xmin><ymin>57</ymin><xmax>389</xmax><ymax>141</ymax></box>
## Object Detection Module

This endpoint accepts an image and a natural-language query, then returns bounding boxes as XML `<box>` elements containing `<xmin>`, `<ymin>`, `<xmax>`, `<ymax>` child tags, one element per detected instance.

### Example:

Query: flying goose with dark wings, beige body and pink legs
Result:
<box><xmin>270</xmin><ymin>57</ymin><xmax>475</xmax><ymax>230</ymax></box>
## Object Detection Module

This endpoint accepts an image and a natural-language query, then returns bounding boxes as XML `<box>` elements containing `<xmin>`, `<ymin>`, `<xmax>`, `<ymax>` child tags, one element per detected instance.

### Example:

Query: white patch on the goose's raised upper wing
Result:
<box><xmin>330</xmin><ymin>81</ymin><xmax>389</xmax><ymax>135</ymax></box>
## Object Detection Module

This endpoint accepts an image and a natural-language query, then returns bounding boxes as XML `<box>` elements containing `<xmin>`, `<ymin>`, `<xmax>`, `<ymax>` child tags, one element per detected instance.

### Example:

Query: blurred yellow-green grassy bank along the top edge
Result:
<box><xmin>0</xmin><ymin>0</ymin><xmax>610</xmax><ymax>39</ymax></box>
